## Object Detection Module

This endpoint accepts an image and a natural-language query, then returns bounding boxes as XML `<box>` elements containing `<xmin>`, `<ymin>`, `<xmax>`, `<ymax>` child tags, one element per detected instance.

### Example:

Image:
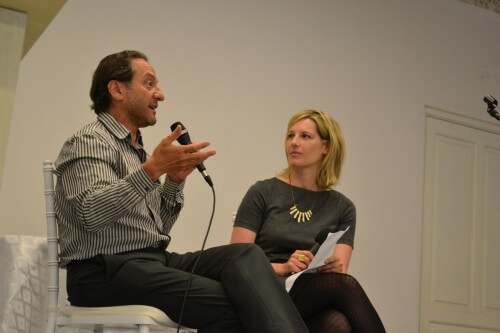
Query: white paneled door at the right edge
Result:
<box><xmin>420</xmin><ymin>116</ymin><xmax>500</xmax><ymax>333</ymax></box>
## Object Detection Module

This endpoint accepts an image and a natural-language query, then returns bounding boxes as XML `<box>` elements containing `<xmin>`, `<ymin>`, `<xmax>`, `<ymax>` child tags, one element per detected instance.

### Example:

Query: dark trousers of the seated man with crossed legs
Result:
<box><xmin>67</xmin><ymin>244</ymin><xmax>308</xmax><ymax>333</ymax></box>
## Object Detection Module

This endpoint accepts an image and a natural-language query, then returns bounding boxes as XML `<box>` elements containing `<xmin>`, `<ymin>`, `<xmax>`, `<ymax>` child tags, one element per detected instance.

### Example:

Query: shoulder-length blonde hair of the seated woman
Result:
<box><xmin>280</xmin><ymin>110</ymin><xmax>345</xmax><ymax>188</ymax></box>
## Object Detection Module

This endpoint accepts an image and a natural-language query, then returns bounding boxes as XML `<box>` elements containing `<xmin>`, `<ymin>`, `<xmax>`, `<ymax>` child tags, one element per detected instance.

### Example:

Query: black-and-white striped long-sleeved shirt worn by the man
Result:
<box><xmin>55</xmin><ymin>113</ymin><xmax>184</xmax><ymax>266</ymax></box>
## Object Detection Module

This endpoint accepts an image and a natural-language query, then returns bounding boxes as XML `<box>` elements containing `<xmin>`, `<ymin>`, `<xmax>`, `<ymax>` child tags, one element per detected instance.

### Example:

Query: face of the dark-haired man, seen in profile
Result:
<box><xmin>123</xmin><ymin>59</ymin><xmax>165</xmax><ymax>129</ymax></box>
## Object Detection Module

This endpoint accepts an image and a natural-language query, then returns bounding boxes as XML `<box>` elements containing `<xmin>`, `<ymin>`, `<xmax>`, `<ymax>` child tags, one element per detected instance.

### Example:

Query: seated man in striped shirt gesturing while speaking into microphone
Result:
<box><xmin>55</xmin><ymin>51</ymin><xmax>307</xmax><ymax>333</ymax></box>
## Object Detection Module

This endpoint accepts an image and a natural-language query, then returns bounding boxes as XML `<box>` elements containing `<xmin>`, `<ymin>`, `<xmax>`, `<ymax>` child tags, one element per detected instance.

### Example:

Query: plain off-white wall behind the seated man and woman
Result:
<box><xmin>0</xmin><ymin>0</ymin><xmax>500</xmax><ymax>332</ymax></box>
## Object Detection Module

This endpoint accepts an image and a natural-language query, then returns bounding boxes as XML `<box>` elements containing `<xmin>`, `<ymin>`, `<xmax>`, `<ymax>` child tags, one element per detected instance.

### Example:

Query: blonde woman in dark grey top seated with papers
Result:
<box><xmin>231</xmin><ymin>110</ymin><xmax>385</xmax><ymax>332</ymax></box>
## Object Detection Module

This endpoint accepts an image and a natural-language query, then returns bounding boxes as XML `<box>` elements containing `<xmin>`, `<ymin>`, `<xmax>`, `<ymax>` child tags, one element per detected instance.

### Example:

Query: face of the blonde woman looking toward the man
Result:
<box><xmin>285</xmin><ymin>118</ymin><xmax>328</xmax><ymax>171</ymax></box>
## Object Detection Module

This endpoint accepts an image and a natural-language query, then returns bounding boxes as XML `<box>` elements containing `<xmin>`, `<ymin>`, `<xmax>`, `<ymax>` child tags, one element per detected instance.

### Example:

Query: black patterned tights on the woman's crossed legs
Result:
<box><xmin>290</xmin><ymin>273</ymin><xmax>385</xmax><ymax>333</ymax></box>
